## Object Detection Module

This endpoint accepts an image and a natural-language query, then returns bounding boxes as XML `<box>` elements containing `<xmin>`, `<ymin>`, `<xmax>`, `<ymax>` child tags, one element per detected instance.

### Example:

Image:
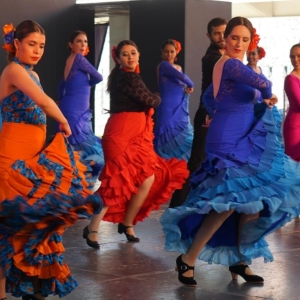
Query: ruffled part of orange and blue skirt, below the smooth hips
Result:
<box><xmin>0</xmin><ymin>132</ymin><xmax>102</xmax><ymax>297</ymax></box>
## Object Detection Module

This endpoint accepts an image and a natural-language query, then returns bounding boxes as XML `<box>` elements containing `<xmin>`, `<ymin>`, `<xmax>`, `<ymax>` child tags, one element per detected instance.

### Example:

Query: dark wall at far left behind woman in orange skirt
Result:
<box><xmin>0</xmin><ymin>0</ymin><xmax>95</xmax><ymax>135</ymax></box>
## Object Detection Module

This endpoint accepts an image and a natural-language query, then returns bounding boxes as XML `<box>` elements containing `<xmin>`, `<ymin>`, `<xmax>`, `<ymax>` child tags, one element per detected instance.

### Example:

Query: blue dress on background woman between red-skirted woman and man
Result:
<box><xmin>154</xmin><ymin>61</ymin><xmax>194</xmax><ymax>161</ymax></box>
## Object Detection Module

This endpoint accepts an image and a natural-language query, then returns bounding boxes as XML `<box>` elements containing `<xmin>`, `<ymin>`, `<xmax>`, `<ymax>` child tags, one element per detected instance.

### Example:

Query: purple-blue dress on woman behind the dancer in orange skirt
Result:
<box><xmin>57</xmin><ymin>54</ymin><xmax>104</xmax><ymax>180</ymax></box>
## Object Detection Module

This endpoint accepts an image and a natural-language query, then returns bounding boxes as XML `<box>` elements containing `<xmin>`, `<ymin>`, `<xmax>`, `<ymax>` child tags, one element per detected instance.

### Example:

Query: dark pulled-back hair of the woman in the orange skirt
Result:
<box><xmin>7</xmin><ymin>20</ymin><xmax>46</xmax><ymax>62</ymax></box>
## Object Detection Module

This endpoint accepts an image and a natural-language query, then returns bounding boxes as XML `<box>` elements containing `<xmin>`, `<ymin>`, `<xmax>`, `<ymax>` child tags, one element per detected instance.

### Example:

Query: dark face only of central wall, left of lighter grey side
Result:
<box><xmin>130</xmin><ymin>0</ymin><xmax>185</xmax><ymax>91</ymax></box>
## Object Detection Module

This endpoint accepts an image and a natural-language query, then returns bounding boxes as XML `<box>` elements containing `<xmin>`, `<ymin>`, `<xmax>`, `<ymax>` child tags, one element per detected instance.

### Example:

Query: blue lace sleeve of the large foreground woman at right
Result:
<box><xmin>224</xmin><ymin>58</ymin><xmax>272</xmax><ymax>99</ymax></box>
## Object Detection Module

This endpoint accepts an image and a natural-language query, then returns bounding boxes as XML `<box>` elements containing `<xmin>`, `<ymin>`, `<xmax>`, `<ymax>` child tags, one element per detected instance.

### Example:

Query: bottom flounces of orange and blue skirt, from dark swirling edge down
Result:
<box><xmin>0</xmin><ymin>194</ymin><xmax>101</xmax><ymax>297</ymax></box>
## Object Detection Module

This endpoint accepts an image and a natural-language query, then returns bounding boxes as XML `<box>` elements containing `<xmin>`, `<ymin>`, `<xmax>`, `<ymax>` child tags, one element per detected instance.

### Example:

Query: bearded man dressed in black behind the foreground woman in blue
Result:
<box><xmin>170</xmin><ymin>18</ymin><xmax>227</xmax><ymax>207</ymax></box>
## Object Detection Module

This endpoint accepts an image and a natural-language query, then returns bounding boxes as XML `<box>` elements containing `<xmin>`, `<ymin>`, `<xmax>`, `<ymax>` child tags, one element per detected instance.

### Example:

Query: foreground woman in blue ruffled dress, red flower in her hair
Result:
<box><xmin>161</xmin><ymin>17</ymin><xmax>300</xmax><ymax>286</ymax></box>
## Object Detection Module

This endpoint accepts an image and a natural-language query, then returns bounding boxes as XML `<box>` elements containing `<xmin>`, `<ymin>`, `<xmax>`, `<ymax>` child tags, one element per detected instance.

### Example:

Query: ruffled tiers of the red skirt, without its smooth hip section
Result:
<box><xmin>98</xmin><ymin>110</ymin><xmax>188</xmax><ymax>224</ymax></box>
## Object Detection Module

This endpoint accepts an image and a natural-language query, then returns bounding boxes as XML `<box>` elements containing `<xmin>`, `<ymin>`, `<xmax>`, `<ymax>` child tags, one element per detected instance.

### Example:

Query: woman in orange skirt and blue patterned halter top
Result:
<box><xmin>0</xmin><ymin>20</ymin><xmax>102</xmax><ymax>300</ymax></box>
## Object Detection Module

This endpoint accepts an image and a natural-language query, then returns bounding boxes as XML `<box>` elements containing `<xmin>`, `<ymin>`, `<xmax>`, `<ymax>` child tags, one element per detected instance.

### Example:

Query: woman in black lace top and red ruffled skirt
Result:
<box><xmin>83</xmin><ymin>40</ymin><xmax>188</xmax><ymax>248</ymax></box>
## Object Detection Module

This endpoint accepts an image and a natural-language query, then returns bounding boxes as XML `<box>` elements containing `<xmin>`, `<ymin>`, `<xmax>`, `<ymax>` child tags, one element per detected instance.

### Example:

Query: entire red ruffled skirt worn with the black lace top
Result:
<box><xmin>98</xmin><ymin>109</ymin><xmax>188</xmax><ymax>224</ymax></box>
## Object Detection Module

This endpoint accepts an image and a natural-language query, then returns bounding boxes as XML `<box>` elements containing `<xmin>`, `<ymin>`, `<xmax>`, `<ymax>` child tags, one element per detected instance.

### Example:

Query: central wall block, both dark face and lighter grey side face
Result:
<box><xmin>130</xmin><ymin>0</ymin><xmax>231</xmax><ymax>122</ymax></box>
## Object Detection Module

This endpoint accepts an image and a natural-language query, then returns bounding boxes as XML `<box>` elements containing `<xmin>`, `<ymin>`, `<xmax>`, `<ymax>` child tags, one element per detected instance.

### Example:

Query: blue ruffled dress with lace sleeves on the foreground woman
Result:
<box><xmin>161</xmin><ymin>59</ymin><xmax>300</xmax><ymax>265</ymax></box>
